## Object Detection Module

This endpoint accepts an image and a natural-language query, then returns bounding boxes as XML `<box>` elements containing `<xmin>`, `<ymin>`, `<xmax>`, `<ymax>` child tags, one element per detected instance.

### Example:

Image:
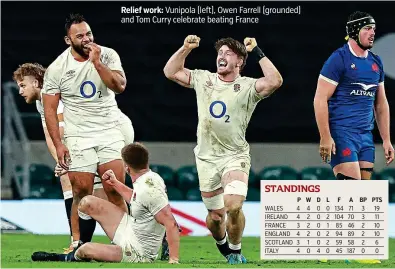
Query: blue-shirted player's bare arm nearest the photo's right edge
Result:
<box><xmin>374</xmin><ymin>83</ymin><xmax>391</xmax><ymax>142</ymax></box>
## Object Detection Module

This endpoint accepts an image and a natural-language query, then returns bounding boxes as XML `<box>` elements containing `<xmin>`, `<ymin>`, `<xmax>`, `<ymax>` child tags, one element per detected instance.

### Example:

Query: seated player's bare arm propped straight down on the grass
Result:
<box><xmin>155</xmin><ymin>205</ymin><xmax>180</xmax><ymax>262</ymax></box>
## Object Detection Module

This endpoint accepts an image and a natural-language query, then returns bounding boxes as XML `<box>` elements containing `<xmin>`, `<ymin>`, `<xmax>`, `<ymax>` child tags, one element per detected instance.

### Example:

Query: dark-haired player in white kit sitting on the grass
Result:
<box><xmin>32</xmin><ymin>143</ymin><xmax>180</xmax><ymax>263</ymax></box>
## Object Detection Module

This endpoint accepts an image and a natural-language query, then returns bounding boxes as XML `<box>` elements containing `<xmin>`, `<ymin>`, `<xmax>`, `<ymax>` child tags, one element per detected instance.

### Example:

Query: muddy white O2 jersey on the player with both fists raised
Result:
<box><xmin>189</xmin><ymin>69</ymin><xmax>263</xmax><ymax>160</ymax></box>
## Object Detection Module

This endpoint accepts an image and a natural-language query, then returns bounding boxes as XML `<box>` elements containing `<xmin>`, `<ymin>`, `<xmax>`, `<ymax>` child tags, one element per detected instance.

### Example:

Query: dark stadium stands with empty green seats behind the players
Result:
<box><xmin>1</xmin><ymin>2</ymin><xmax>395</xmax><ymax>237</ymax></box>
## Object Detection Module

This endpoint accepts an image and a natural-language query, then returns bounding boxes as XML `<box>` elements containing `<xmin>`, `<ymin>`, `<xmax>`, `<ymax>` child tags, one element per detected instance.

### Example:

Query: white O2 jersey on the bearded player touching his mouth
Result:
<box><xmin>43</xmin><ymin>46</ymin><xmax>124</xmax><ymax>137</ymax></box>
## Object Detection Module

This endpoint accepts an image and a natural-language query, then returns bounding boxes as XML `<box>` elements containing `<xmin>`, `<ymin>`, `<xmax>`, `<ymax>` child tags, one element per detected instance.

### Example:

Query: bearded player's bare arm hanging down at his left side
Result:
<box><xmin>42</xmin><ymin>93</ymin><xmax>62</xmax><ymax>149</ymax></box>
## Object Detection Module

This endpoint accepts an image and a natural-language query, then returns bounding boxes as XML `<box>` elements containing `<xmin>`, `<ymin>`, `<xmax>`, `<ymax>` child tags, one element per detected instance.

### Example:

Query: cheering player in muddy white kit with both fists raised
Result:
<box><xmin>164</xmin><ymin>35</ymin><xmax>283</xmax><ymax>264</ymax></box>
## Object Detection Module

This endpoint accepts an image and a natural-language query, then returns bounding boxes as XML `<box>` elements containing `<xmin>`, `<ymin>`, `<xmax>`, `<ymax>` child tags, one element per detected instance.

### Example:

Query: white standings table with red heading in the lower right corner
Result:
<box><xmin>261</xmin><ymin>180</ymin><xmax>389</xmax><ymax>260</ymax></box>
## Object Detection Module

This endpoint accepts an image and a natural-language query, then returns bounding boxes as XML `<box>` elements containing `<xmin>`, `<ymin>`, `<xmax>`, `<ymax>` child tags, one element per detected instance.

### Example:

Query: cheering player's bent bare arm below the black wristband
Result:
<box><xmin>255</xmin><ymin>57</ymin><xmax>283</xmax><ymax>97</ymax></box>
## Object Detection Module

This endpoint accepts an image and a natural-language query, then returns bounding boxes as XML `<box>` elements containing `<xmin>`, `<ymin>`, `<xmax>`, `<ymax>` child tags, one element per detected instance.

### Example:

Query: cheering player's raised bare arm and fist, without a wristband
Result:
<box><xmin>163</xmin><ymin>35</ymin><xmax>200</xmax><ymax>87</ymax></box>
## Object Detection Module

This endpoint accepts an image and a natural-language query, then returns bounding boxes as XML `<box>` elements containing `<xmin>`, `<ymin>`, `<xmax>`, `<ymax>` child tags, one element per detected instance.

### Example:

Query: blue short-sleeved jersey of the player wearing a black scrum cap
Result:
<box><xmin>320</xmin><ymin>43</ymin><xmax>384</xmax><ymax>131</ymax></box>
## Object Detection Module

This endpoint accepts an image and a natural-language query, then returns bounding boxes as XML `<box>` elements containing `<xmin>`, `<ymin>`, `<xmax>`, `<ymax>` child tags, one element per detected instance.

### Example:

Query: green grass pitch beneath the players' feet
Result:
<box><xmin>1</xmin><ymin>234</ymin><xmax>395</xmax><ymax>268</ymax></box>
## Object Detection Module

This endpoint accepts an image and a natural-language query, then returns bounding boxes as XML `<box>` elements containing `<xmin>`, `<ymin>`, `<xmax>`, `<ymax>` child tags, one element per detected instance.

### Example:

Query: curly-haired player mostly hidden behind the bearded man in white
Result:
<box><xmin>13</xmin><ymin>63</ymin><xmax>107</xmax><ymax>253</ymax></box>
